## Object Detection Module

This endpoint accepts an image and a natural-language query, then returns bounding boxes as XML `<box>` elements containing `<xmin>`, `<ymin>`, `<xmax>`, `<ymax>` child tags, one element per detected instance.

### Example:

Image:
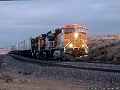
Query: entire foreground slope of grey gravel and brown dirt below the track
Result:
<box><xmin>0</xmin><ymin>55</ymin><xmax>120</xmax><ymax>90</ymax></box>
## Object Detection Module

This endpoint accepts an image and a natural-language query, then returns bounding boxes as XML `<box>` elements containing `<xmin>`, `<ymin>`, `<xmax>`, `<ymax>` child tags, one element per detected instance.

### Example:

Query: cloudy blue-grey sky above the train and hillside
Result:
<box><xmin>0</xmin><ymin>0</ymin><xmax>120</xmax><ymax>47</ymax></box>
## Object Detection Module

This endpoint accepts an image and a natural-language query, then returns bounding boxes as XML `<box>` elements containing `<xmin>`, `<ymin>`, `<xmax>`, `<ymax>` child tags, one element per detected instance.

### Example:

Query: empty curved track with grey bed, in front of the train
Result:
<box><xmin>10</xmin><ymin>54</ymin><xmax>120</xmax><ymax>73</ymax></box>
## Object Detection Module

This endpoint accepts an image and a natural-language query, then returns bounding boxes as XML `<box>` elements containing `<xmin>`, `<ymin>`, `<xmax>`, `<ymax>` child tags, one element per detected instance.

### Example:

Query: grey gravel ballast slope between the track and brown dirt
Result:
<box><xmin>4</xmin><ymin>56</ymin><xmax>120</xmax><ymax>90</ymax></box>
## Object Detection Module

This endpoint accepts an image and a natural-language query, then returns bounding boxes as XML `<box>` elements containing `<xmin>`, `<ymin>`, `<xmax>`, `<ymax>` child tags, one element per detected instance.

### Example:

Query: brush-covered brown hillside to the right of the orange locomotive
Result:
<box><xmin>84</xmin><ymin>34</ymin><xmax>120</xmax><ymax>62</ymax></box>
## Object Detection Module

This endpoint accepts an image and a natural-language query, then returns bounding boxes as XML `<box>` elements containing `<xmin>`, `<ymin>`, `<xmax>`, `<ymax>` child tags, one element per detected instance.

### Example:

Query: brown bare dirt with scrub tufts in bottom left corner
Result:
<box><xmin>0</xmin><ymin>71</ymin><xmax>85</xmax><ymax>90</ymax></box>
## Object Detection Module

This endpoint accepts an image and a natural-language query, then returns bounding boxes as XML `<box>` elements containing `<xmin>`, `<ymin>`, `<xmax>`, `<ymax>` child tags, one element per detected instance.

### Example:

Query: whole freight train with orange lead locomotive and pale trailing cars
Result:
<box><xmin>10</xmin><ymin>24</ymin><xmax>88</xmax><ymax>60</ymax></box>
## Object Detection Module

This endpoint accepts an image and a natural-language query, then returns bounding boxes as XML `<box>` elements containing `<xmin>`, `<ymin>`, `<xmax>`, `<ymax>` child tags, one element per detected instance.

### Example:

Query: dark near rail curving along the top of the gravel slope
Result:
<box><xmin>10</xmin><ymin>54</ymin><xmax>120</xmax><ymax>73</ymax></box>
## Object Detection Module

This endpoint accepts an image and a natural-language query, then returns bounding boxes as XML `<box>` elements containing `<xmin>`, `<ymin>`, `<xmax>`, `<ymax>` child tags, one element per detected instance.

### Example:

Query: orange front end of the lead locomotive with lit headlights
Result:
<box><xmin>63</xmin><ymin>24</ymin><xmax>88</xmax><ymax>57</ymax></box>
